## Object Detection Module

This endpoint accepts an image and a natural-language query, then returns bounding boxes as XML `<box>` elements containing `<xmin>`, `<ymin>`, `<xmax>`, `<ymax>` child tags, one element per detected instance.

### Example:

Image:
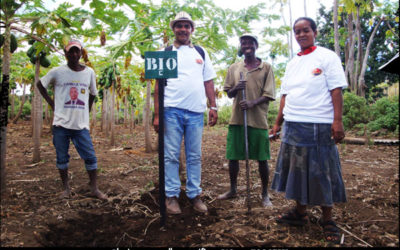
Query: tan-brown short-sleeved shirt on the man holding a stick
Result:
<box><xmin>224</xmin><ymin>61</ymin><xmax>275</xmax><ymax>129</ymax></box>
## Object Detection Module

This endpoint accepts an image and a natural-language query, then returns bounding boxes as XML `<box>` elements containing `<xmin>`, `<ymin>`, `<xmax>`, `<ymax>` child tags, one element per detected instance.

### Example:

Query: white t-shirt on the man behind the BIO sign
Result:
<box><xmin>164</xmin><ymin>44</ymin><xmax>217</xmax><ymax>113</ymax></box>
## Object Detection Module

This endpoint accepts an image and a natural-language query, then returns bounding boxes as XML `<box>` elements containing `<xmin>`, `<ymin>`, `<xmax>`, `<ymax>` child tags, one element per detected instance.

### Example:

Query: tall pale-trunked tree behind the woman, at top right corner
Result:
<box><xmin>317</xmin><ymin>0</ymin><xmax>399</xmax><ymax>96</ymax></box>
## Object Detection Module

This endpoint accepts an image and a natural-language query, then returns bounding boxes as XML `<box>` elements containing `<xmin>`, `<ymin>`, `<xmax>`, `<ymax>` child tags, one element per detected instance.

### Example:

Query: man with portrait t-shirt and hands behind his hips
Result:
<box><xmin>36</xmin><ymin>40</ymin><xmax>107</xmax><ymax>199</ymax></box>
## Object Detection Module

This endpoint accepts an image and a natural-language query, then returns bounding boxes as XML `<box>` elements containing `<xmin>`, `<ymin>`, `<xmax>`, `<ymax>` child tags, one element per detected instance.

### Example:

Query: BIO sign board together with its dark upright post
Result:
<box><xmin>144</xmin><ymin>51</ymin><xmax>178</xmax><ymax>227</ymax></box>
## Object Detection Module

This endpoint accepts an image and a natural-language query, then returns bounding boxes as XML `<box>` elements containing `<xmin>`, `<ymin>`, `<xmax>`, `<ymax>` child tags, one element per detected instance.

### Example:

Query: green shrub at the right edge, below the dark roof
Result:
<box><xmin>367</xmin><ymin>95</ymin><xmax>399</xmax><ymax>132</ymax></box>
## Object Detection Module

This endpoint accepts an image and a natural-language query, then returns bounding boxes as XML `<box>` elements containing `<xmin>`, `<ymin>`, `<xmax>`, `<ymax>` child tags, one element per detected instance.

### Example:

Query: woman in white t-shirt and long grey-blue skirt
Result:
<box><xmin>270</xmin><ymin>17</ymin><xmax>347</xmax><ymax>243</ymax></box>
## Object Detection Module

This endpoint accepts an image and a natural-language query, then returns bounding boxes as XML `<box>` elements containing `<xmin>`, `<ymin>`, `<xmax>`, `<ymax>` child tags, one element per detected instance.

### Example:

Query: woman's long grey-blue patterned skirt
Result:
<box><xmin>271</xmin><ymin>121</ymin><xmax>346</xmax><ymax>207</ymax></box>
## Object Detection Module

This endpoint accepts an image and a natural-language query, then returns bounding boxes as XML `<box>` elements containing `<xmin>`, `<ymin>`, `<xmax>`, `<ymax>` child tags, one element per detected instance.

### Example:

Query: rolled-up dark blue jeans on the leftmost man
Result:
<box><xmin>53</xmin><ymin>126</ymin><xmax>97</xmax><ymax>171</ymax></box>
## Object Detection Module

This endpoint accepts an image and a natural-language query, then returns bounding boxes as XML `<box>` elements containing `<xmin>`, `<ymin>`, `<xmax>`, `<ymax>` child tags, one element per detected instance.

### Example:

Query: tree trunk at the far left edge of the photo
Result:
<box><xmin>0</xmin><ymin>22</ymin><xmax>11</xmax><ymax>194</ymax></box>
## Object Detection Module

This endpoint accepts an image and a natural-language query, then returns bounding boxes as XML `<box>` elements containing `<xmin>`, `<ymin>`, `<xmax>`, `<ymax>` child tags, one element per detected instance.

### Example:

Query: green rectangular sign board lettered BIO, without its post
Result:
<box><xmin>144</xmin><ymin>51</ymin><xmax>178</xmax><ymax>79</ymax></box>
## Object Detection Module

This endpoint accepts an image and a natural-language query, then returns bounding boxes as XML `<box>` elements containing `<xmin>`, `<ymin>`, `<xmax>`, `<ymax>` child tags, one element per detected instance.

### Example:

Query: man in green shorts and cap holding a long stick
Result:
<box><xmin>217</xmin><ymin>34</ymin><xmax>275</xmax><ymax>207</ymax></box>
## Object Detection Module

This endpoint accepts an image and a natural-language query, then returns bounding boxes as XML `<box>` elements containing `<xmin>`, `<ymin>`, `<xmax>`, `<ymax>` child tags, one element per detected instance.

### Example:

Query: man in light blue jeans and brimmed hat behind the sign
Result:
<box><xmin>154</xmin><ymin>12</ymin><xmax>218</xmax><ymax>214</ymax></box>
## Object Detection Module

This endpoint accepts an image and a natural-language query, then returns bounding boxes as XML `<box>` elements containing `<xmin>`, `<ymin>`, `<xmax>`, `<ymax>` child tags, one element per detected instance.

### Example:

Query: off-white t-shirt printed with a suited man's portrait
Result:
<box><xmin>40</xmin><ymin>65</ymin><xmax>97</xmax><ymax>130</ymax></box>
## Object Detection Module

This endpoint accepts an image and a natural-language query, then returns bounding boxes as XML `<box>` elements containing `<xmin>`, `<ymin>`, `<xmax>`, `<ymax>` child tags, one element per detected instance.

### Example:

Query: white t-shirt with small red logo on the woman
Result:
<box><xmin>281</xmin><ymin>47</ymin><xmax>347</xmax><ymax>123</ymax></box>
